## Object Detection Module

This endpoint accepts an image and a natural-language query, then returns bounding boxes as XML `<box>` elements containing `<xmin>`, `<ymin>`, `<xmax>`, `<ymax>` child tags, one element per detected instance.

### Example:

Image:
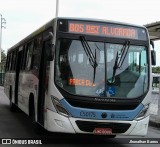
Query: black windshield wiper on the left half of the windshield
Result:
<box><xmin>80</xmin><ymin>36</ymin><xmax>98</xmax><ymax>83</ymax></box>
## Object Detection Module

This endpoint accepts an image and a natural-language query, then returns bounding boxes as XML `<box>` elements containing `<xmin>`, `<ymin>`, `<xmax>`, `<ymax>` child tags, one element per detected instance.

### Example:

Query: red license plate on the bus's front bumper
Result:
<box><xmin>93</xmin><ymin>128</ymin><xmax>112</xmax><ymax>135</ymax></box>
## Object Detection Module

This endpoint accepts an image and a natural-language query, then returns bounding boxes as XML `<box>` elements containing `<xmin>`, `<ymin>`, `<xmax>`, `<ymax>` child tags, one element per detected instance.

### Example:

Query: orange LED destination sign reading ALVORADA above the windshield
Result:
<box><xmin>68</xmin><ymin>21</ymin><xmax>146</xmax><ymax>40</ymax></box>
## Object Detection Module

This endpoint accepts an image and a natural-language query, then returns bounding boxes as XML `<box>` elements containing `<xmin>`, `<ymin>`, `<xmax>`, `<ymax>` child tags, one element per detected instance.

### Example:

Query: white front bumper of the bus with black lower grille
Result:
<box><xmin>45</xmin><ymin>109</ymin><xmax>149</xmax><ymax>136</ymax></box>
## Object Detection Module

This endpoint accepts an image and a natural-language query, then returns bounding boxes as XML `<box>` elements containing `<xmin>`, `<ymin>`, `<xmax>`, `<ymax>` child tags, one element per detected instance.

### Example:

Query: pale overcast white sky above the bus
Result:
<box><xmin>0</xmin><ymin>0</ymin><xmax>160</xmax><ymax>66</ymax></box>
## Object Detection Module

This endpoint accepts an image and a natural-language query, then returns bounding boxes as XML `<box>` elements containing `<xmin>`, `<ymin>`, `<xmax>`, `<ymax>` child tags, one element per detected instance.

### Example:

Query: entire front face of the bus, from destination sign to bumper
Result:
<box><xmin>47</xmin><ymin>19</ymin><xmax>154</xmax><ymax>136</ymax></box>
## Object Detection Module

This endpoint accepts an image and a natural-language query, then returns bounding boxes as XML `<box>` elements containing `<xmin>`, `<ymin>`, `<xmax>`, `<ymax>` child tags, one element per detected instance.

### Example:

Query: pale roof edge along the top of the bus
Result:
<box><xmin>8</xmin><ymin>17</ymin><xmax>146</xmax><ymax>52</ymax></box>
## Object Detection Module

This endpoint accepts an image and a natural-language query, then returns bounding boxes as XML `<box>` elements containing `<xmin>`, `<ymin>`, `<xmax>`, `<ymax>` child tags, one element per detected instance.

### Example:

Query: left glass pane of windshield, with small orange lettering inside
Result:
<box><xmin>56</xmin><ymin>39</ymin><xmax>105</xmax><ymax>96</ymax></box>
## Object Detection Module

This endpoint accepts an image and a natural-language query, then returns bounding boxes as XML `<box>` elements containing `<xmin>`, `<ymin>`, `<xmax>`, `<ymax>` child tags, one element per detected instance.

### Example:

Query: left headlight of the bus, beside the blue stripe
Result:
<box><xmin>51</xmin><ymin>96</ymin><xmax>70</xmax><ymax>117</ymax></box>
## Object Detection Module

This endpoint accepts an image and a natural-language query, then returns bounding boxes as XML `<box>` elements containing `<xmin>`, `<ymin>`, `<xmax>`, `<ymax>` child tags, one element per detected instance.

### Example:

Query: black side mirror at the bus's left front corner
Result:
<box><xmin>46</xmin><ymin>32</ymin><xmax>55</xmax><ymax>61</ymax></box>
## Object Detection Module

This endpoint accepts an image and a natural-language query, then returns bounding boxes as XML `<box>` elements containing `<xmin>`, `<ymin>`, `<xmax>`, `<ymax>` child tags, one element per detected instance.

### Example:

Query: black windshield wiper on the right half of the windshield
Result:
<box><xmin>112</xmin><ymin>41</ymin><xmax>130</xmax><ymax>83</ymax></box>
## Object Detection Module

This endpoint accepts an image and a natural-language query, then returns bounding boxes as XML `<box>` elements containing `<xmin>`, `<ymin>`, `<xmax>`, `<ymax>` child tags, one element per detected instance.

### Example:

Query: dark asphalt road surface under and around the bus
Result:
<box><xmin>0</xmin><ymin>87</ymin><xmax>160</xmax><ymax>147</ymax></box>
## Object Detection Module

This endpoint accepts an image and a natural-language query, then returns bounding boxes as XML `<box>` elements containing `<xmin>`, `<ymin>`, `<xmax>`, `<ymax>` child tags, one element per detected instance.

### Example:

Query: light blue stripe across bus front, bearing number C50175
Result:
<box><xmin>60</xmin><ymin>99</ymin><xmax>144</xmax><ymax>121</ymax></box>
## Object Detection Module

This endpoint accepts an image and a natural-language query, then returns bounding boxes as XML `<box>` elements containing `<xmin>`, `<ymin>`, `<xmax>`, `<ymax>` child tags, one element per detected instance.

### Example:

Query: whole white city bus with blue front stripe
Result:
<box><xmin>4</xmin><ymin>18</ymin><xmax>155</xmax><ymax>136</ymax></box>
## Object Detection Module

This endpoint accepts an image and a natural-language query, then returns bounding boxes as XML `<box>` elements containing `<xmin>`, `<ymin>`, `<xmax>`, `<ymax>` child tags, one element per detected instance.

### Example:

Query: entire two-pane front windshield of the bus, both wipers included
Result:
<box><xmin>55</xmin><ymin>38</ymin><xmax>148</xmax><ymax>98</ymax></box>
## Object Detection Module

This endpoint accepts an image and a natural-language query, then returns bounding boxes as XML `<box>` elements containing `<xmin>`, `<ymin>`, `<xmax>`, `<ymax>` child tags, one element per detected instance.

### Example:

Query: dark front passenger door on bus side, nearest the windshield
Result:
<box><xmin>38</xmin><ymin>40</ymin><xmax>50</xmax><ymax>125</ymax></box>
